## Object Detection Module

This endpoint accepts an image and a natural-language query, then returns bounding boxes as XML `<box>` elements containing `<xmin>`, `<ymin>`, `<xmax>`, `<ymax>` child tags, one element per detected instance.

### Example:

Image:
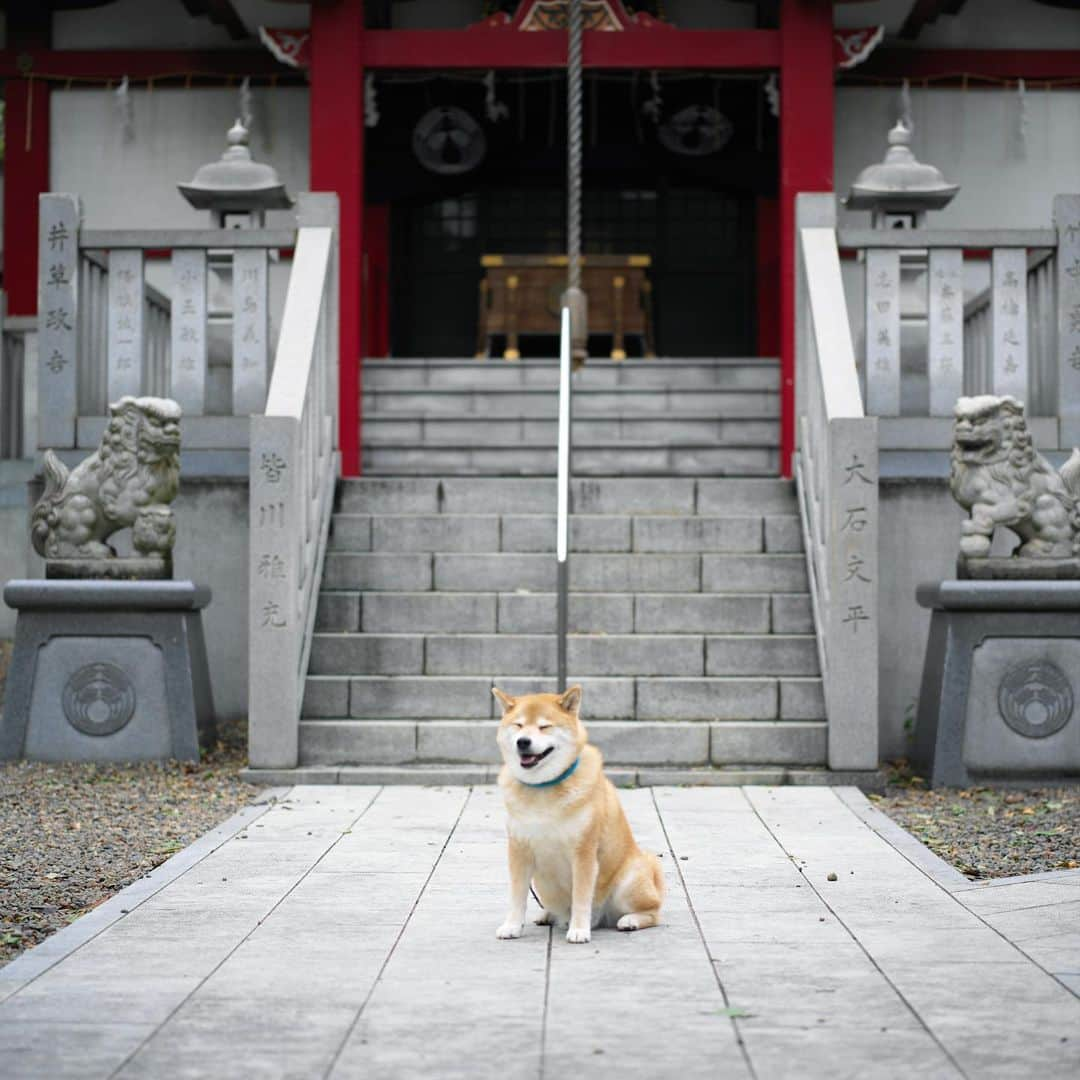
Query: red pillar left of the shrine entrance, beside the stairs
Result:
<box><xmin>309</xmin><ymin>0</ymin><xmax>364</xmax><ymax>476</ymax></box>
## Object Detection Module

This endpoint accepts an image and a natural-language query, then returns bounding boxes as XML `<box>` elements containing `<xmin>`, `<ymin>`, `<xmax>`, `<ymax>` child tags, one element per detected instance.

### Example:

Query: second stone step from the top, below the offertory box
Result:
<box><xmin>361</xmin><ymin>387</ymin><xmax>780</xmax><ymax>421</ymax></box>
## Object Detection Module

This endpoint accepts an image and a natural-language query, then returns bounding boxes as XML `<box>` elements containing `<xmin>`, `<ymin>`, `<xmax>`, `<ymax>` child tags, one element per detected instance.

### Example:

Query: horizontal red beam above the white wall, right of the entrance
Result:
<box><xmin>841</xmin><ymin>49</ymin><xmax>1080</xmax><ymax>82</ymax></box>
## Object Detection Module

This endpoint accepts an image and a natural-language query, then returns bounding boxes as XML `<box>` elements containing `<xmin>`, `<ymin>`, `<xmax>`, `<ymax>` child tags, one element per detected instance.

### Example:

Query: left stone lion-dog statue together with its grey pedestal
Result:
<box><xmin>0</xmin><ymin>397</ymin><xmax>214</xmax><ymax>761</ymax></box>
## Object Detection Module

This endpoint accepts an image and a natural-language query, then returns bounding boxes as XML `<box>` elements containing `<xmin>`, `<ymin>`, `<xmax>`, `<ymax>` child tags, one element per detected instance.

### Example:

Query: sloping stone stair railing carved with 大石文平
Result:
<box><xmin>795</xmin><ymin>194</ymin><xmax>879</xmax><ymax>769</ymax></box>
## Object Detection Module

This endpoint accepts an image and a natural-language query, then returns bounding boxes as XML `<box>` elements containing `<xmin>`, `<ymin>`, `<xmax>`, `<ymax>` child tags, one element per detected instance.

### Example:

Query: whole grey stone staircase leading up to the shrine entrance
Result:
<box><xmin>300</xmin><ymin>361</ymin><xmax>826</xmax><ymax>783</ymax></box>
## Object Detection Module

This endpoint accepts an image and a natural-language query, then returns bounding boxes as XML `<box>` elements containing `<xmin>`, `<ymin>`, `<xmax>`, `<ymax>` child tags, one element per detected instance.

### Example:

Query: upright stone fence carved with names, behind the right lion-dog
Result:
<box><xmin>837</xmin><ymin>195</ymin><xmax>1080</xmax><ymax>449</ymax></box>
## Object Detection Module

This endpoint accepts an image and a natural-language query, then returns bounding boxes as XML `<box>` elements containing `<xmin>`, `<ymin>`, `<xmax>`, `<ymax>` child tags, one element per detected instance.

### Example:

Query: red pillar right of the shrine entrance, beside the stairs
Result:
<box><xmin>780</xmin><ymin>0</ymin><xmax>833</xmax><ymax>476</ymax></box>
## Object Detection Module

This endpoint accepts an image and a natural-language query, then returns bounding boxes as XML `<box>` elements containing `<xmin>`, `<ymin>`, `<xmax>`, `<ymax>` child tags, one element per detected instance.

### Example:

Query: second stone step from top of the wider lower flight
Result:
<box><xmin>329</xmin><ymin>514</ymin><xmax>802</xmax><ymax>554</ymax></box>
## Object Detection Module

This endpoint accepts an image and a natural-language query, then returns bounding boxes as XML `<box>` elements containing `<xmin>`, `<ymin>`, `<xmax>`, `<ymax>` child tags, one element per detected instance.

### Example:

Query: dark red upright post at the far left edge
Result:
<box><xmin>3</xmin><ymin>79</ymin><xmax>49</xmax><ymax>315</ymax></box>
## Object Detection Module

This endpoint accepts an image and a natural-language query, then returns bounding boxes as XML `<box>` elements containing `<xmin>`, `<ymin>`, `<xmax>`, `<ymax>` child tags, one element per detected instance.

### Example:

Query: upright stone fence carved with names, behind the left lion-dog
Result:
<box><xmin>37</xmin><ymin>194</ymin><xmax>295</xmax><ymax>475</ymax></box>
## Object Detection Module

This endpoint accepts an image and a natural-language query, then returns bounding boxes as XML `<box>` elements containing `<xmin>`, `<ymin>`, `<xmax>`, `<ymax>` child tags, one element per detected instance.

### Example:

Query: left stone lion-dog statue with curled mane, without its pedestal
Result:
<box><xmin>30</xmin><ymin>396</ymin><xmax>180</xmax><ymax>578</ymax></box>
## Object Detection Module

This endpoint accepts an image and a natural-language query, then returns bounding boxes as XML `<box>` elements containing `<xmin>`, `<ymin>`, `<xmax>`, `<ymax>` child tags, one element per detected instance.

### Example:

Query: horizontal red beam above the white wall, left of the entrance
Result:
<box><xmin>0</xmin><ymin>49</ymin><xmax>289</xmax><ymax>81</ymax></box>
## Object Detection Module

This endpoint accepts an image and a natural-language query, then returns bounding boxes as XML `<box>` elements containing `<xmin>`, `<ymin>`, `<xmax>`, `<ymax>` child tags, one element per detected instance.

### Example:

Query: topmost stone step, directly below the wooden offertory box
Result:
<box><xmin>363</xmin><ymin>357</ymin><xmax>780</xmax><ymax>394</ymax></box>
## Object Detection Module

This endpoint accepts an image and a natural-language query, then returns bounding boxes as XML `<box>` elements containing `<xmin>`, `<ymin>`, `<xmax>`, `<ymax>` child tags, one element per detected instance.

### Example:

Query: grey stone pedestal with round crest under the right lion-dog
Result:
<box><xmin>913</xmin><ymin>580</ymin><xmax>1080</xmax><ymax>787</ymax></box>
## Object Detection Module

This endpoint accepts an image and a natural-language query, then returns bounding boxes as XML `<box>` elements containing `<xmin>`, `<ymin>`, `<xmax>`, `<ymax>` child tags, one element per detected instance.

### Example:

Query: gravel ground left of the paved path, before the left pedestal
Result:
<box><xmin>0</xmin><ymin>731</ymin><xmax>259</xmax><ymax>967</ymax></box>
